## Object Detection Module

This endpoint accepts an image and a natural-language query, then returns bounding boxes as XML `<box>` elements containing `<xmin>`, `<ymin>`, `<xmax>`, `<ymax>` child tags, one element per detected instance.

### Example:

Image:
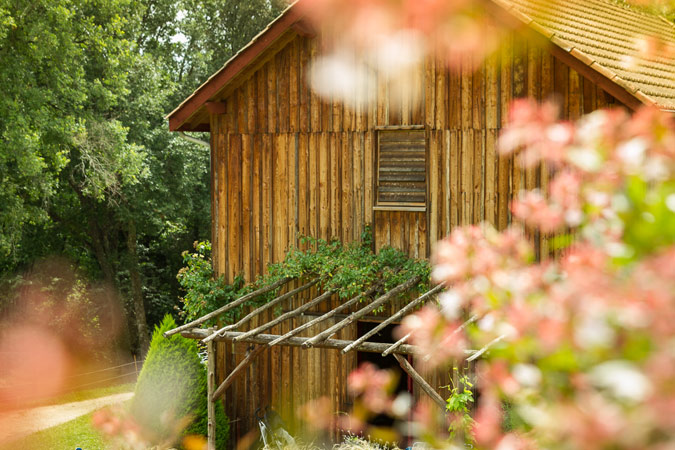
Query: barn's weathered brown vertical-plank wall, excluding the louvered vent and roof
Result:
<box><xmin>211</xmin><ymin>31</ymin><xmax>618</xmax><ymax>446</ymax></box>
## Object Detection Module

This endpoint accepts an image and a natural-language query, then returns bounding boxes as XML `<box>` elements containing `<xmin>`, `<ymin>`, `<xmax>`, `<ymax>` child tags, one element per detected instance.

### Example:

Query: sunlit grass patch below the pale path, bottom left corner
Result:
<box><xmin>0</xmin><ymin>413</ymin><xmax>105</xmax><ymax>450</ymax></box>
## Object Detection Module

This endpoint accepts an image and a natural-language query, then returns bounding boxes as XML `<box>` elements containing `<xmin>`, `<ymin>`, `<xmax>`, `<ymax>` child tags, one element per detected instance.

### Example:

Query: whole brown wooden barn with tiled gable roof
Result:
<box><xmin>168</xmin><ymin>0</ymin><xmax>675</xmax><ymax>442</ymax></box>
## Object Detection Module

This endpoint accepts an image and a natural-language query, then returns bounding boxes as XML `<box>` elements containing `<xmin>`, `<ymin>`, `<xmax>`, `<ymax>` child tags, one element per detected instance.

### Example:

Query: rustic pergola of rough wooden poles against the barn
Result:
<box><xmin>164</xmin><ymin>276</ymin><xmax>492</xmax><ymax>450</ymax></box>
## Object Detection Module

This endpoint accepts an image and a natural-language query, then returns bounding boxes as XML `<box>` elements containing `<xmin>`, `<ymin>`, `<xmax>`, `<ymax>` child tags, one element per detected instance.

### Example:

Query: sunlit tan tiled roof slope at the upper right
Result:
<box><xmin>499</xmin><ymin>0</ymin><xmax>675</xmax><ymax>110</ymax></box>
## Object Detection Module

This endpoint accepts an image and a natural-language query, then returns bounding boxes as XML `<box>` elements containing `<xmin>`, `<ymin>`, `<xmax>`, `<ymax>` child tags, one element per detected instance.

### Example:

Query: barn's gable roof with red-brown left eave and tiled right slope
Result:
<box><xmin>167</xmin><ymin>0</ymin><xmax>675</xmax><ymax>131</ymax></box>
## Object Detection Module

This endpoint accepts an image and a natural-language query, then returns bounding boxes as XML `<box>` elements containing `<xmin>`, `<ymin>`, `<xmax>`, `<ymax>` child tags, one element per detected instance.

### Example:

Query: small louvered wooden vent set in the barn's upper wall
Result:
<box><xmin>377</xmin><ymin>130</ymin><xmax>427</xmax><ymax>207</ymax></box>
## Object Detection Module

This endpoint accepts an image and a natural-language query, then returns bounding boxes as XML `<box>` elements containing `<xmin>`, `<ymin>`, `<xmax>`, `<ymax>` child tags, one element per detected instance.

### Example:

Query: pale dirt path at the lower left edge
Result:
<box><xmin>0</xmin><ymin>392</ymin><xmax>134</xmax><ymax>444</ymax></box>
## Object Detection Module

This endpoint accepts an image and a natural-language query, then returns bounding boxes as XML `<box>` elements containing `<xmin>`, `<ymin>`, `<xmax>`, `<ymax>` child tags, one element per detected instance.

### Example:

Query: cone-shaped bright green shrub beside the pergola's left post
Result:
<box><xmin>131</xmin><ymin>315</ymin><xmax>229</xmax><ymax>448</ymax></box>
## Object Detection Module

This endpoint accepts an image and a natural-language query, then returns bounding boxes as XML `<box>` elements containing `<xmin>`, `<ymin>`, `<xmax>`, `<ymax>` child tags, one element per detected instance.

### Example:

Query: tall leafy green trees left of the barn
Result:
<box><xmin>0</xmin><ymin>0</ymin><xmax>282</xmax><ymax>349</ymax></box>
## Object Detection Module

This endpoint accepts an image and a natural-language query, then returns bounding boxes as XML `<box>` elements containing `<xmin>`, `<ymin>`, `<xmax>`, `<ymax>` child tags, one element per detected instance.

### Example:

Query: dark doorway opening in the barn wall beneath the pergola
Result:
<box><xmin>356</xmin><ymin>322</ymin><xmax>413</xmax><ymax>448</ymax></box>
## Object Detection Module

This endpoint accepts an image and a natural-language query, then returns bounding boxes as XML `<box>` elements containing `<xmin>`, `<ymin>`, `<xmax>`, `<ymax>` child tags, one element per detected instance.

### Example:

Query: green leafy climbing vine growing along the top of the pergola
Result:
<box><xmin>177</xmin><ymin>227</ymin><xmax>430</xmax><ymax>322</ymax></box>
